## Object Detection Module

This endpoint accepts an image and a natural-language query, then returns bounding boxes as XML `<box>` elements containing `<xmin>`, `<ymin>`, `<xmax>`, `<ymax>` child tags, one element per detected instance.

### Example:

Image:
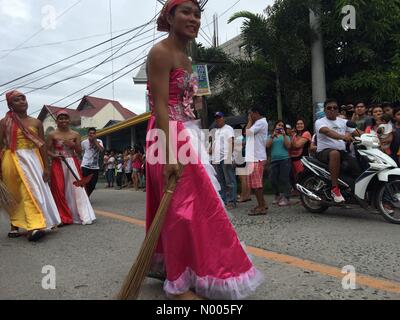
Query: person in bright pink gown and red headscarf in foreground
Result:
<box><xmin>146</xmin><ymin>0</ymin><xmax>263</xmax><ymax>299</ymax></box>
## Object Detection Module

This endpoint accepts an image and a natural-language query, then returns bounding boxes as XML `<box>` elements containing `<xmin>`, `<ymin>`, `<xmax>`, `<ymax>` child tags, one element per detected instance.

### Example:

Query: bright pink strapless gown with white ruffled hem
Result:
<box><xmin>146</xmin><ymin>69</ymin><xmax>263</xmax><ymax>300</ymax></box>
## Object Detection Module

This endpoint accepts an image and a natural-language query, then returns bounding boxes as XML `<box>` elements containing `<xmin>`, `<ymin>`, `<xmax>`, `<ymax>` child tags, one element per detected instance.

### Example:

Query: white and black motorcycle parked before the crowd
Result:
<box><xmin>296</xmin><ymin>121</ymin><xmax>400</xmax><ymax>224</ymax></box>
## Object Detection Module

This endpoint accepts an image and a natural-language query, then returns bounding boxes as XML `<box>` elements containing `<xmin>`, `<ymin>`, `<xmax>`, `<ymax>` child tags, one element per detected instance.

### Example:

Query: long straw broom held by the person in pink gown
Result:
<box><xmin>118</xmin><ymin>165</ymin><xmax>184</xmax><ymax>300</ymax></box>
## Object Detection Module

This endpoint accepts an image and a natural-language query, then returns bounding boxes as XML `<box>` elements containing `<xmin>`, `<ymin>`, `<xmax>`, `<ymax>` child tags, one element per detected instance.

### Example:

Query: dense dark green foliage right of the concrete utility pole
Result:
<box><xmin>322</xmin><ymin>0</ymin><xmax>400</xmax><ymax>102</ymax></box>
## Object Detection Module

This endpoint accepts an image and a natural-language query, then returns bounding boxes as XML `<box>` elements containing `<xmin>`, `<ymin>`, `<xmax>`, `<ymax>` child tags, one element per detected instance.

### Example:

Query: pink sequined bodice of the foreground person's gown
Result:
<box><xmin>147</xmin><ymin>68</ymin><xmax>198</xmax><ymax>122</ymax></box>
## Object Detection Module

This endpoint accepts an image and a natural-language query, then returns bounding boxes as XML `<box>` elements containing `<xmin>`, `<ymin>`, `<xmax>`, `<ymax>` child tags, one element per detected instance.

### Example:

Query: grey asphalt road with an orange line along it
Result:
<box><xmin>0</xmin><ymin>189</ymin><xmax>400</xmax><ymax>300</ymax></box>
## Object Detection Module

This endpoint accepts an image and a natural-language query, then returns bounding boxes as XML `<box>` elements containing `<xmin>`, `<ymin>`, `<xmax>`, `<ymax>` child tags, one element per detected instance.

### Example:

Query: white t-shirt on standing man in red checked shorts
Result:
<box><xmin>246</xmin><ymin>118</ymin><xmax>268</xmax><ymax>162</ymax></box>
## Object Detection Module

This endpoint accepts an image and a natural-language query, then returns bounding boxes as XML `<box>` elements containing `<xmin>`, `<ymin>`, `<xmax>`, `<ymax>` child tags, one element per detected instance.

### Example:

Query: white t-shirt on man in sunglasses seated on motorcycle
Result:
<box><xmin>315</xmin><ymin>117</ymin><xmax>355</xmax><ymax>152</ymax></box>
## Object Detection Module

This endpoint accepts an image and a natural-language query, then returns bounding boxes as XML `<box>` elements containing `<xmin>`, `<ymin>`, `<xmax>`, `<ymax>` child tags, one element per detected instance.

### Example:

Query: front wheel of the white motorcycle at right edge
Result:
<box><xmin>376</xmin><ymin>180</ymin><xmax>400</xmax><ymax>224</ymax></box>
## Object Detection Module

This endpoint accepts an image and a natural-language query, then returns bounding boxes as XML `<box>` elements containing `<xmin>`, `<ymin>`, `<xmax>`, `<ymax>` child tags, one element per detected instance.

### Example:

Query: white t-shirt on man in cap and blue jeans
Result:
<box><xmin>212</xmin><ymin>124</ymin><xmax>235</xmax><ymax>163</ymax></box>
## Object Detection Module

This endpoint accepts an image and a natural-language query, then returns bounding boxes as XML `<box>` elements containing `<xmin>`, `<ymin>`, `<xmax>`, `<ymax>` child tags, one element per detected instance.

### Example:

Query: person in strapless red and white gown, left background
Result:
<box><xmin>47</xmin><ymin>110</ymin><xmax>96</xmax><ymax>225</ymax></box>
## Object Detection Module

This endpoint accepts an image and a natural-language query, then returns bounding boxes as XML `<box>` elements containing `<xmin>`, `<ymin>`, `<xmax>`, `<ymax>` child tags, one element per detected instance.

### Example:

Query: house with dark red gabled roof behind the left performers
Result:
<box><xmin>38</xmin><ymin>96</ymin><xmax>136</xmax><ymax>132</ymax></box>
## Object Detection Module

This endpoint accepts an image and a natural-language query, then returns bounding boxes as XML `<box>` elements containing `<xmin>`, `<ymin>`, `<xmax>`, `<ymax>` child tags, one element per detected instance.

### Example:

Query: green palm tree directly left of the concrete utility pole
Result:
<box><xmin>229</xmin><ymin>0</ymin><xmax>312</xmax><ymax>123</ymax></box>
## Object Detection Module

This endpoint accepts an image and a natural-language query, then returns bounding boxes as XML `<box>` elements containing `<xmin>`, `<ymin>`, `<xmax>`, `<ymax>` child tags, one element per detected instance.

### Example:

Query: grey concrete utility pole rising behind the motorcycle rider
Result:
<box><xmin>310</xmin><ymin>8</ymin><xmax>326</xmax><ymax>122</ymax></box>
